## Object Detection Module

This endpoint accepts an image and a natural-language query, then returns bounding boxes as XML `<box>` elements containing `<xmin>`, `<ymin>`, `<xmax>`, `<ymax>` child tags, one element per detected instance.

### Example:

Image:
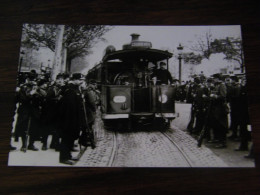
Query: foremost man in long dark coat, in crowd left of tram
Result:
<box><xmin>59</xmin><ymin>73</ymin><xmax>84</xmax><ymax>165</ymax></box>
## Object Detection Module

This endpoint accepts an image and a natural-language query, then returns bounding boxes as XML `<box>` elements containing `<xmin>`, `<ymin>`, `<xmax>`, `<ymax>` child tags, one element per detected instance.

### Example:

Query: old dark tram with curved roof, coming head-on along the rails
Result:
<box><xmin>86</xmin><ymin>34</ymin><xmax>177</xmax><ymax>128</ymax></box>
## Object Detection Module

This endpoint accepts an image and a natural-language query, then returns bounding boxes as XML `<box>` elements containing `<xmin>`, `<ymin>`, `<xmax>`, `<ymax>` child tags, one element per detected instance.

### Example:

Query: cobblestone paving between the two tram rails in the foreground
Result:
<box><xmin>113</xmin><ymin>132</ymin><xmax>193</xmax><ymax>167</ymax></box>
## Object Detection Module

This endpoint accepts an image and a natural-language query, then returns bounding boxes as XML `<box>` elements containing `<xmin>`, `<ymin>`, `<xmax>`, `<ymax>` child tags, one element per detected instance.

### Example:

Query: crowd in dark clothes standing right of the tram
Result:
<box><xmin>175</xmin><ymin>74</ymin><xmax>252</xmax><ymax>157</ymax></box>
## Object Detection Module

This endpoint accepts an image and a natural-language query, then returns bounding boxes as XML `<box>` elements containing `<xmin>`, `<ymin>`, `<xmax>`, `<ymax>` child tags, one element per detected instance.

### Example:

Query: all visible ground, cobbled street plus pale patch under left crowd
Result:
<box><xmin>9</xmin><ymin>104</ymin><xmax>254</xmax><ymax>167</ymax></box>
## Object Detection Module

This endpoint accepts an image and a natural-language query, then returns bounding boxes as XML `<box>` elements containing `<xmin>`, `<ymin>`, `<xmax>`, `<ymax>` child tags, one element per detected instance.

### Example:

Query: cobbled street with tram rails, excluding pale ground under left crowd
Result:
<box><xmin>76</xmin><ymin>104</ymin><xmax>254</xmax><ymax>167</ymax></box>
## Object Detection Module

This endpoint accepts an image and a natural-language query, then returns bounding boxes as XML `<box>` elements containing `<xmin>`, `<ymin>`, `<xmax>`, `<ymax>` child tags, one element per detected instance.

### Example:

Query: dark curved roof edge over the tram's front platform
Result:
<box><xmin>103</xmin><ymin>49</ymin><xmax>173</xmax><ymax>62</ymax></box>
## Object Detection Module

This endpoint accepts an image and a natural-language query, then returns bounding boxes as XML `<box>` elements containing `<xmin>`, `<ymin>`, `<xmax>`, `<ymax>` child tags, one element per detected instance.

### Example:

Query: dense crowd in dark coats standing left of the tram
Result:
<box><xmin>10</xmin><ymin>71</ymin><xmax>99</xmax><ymax>165</ymax></box>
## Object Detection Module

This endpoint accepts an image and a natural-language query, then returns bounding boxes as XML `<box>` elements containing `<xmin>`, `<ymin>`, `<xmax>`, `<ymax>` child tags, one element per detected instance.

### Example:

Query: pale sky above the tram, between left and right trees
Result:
<box><xmin>88</xmin><ymin>25</ymin><xmax>241</xmax><ymax>65</ymax></box>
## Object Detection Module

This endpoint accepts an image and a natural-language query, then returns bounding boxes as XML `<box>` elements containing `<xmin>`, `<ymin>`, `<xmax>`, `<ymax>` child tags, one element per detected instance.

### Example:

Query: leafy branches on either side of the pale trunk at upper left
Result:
<box><xmin>22</xmin><ymin>24</ymin><xmax>111</xmax><ymax>72</ymax></box>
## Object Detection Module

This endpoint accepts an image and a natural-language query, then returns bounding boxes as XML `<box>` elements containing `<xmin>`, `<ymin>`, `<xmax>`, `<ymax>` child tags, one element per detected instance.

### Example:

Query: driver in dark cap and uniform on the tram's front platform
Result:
<box><xmin>151</xmin><ymin>62</ymin><xmax>173</xmax><ymax>85</ymax></box>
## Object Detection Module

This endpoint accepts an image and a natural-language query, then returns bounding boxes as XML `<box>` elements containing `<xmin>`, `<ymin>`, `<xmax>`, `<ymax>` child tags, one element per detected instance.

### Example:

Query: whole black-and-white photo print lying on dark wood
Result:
<box><xmin>8</xmin><ymin>24</ymin><xmax>255</xmax><ymax>168</ymax></box>
